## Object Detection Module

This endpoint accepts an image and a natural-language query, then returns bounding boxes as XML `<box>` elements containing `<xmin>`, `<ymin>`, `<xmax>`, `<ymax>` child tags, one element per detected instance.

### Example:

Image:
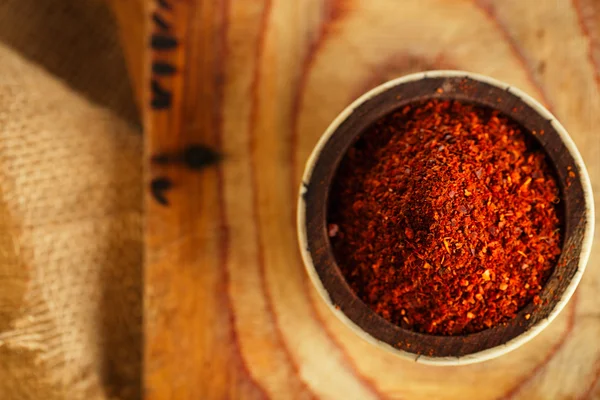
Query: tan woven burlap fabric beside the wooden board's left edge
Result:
<box><xmin>0</xmin><ymin>0</ymin><xmax>142</xmax><ymax>400</ymax></box>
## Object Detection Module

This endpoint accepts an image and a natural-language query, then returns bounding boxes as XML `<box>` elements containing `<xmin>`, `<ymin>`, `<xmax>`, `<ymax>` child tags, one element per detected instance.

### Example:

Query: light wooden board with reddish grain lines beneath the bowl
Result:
<box><xmin>130</xmin><ymin>0</ymin><xmax>600</xmax><ymax>399</ymax></box>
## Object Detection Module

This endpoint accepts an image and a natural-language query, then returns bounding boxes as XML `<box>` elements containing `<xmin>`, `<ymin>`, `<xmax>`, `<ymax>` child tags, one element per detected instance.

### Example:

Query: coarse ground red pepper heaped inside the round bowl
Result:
<box><xmin>328</xmin><ymin>100</ymin><xmax>561</xmax><ymax>335</ymax></box>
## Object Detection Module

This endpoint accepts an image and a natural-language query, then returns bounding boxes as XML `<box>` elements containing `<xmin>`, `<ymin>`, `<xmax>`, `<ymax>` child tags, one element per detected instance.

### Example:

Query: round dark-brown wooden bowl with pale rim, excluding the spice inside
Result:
<box><xmin>298</xmin><ymin>71</ymin><xmax>594</xmax><ymax>365</ymax></box>
